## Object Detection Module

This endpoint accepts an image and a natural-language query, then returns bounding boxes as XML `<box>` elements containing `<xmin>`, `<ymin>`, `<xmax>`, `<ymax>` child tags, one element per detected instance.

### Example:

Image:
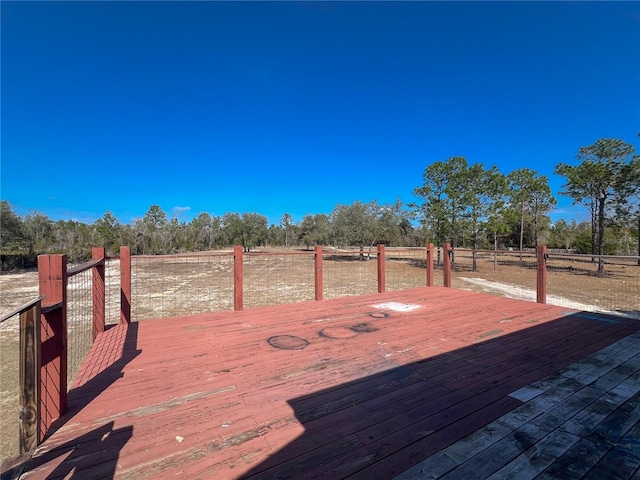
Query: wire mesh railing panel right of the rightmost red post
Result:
<box><xmin>547</xmin><ymin>254</ymin><xmax>640</xmax><ymax>318</ymax></box>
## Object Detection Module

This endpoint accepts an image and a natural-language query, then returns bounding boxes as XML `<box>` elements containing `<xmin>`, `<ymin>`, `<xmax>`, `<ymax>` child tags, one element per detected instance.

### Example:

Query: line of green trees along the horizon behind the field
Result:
<box><xmin>0</xmin><ymin>139</ymin><xmax>640</xmax><ymax>269</ymax></box>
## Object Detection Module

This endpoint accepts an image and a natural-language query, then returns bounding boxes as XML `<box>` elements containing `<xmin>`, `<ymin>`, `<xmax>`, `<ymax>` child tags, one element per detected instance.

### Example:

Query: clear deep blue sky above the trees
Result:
<box><xmin>0</xmin><ymin>1</ymin><xmax>640</xmax><ymax>227</ymax></box>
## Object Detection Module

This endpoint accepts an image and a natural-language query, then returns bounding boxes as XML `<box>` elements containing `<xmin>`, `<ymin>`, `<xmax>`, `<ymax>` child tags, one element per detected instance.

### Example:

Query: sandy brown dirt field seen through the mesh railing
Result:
<box><xmin>0</xmin><ymin>249</ymin><xmax>640</xmax><ymax>458</ymax></box>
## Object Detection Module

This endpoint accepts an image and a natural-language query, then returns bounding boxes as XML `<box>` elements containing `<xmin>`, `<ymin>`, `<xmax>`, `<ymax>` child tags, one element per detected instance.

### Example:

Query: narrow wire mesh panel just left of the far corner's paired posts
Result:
<box><xmin>385</xmin><ymin>248</ymin><xmax>427</xmax><ymax>291</ymax></box>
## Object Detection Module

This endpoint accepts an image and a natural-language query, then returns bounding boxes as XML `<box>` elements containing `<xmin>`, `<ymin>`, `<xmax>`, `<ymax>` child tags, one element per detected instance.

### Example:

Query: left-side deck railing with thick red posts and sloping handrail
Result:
<box><xmin>0</xmin><ymin>247</ymin><xmax>130</xmax><ymax>458</ymax></box>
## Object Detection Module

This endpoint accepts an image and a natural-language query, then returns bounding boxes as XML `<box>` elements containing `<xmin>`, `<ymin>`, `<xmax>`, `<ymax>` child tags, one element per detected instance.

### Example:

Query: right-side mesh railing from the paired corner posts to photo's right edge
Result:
<box><xmin>442</xmin><ymin>247</ymin><xmax>640</xmax><ymax>318</ymax></box>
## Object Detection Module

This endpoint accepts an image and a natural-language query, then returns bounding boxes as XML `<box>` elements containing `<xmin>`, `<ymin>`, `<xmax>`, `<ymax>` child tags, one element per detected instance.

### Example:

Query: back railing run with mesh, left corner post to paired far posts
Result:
<box><xmin>121</xmin><ymin>245</ymin><xmax>440</xmax><ymax>321</ymax></box>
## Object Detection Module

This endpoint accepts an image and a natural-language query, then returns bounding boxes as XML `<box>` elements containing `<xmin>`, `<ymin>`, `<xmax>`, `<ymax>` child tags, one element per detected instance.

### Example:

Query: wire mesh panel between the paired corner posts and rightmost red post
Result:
<box><xmin>451</xmin><ymin>249</ymin><xmax>537</xmax><ymax>302</ymax></box>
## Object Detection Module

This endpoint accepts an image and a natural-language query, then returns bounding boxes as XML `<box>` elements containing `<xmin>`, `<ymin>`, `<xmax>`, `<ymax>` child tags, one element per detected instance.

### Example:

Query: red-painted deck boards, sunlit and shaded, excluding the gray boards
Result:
<box><xmin>11</xmin><ymin>287</ymin><xmax>640</xmax><ymax>479</ymax></box>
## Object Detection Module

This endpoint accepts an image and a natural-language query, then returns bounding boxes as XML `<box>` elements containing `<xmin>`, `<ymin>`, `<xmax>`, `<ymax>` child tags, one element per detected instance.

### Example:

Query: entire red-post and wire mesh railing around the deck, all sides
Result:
<box><xmin>3</xmin><ymin>244</ymin><xmax>640</xmax><ymax>462</ymax></box>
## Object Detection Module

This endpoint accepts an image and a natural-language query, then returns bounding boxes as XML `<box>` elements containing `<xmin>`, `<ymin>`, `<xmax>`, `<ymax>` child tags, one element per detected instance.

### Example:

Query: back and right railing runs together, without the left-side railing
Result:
<box><xmin>114</xmin><ymin>244</ymin><xmax>640</xmax><ymax>320</ymax></box>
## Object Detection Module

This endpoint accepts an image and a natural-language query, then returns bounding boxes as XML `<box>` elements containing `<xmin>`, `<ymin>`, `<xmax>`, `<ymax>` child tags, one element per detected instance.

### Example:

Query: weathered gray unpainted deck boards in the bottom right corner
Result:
<box><xmin>394</xmin><ymin>334</ymin><xmax>640</xmax><ymax>480</ymax></box>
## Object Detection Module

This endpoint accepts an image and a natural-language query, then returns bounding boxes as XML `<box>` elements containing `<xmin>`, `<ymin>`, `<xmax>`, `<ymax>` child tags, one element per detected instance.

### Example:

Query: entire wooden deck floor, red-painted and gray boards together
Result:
<box><xmin>8</xmin><ymin>287</ymin><xmax>640</xmax><ymax>480</ymax></box>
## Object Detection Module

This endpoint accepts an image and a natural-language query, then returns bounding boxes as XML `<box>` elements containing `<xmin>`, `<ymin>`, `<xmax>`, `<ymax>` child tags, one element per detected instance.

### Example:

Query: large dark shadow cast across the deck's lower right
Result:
<box><xmin>242</xmin><ymin>313</ymin><xmax>640</xmax><ymax>480</ymax></box>
